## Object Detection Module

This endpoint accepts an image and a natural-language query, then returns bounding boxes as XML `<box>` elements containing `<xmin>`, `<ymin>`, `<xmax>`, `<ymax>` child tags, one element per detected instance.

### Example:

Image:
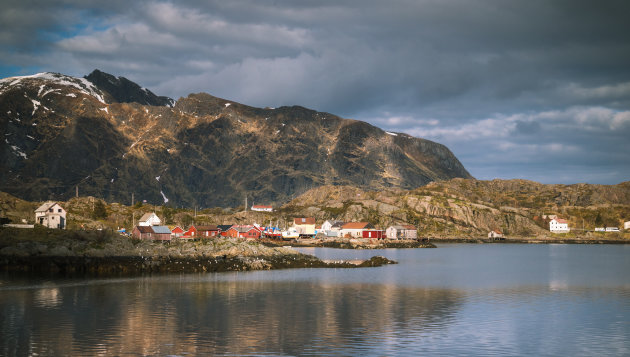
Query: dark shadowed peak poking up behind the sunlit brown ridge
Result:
<box><xmin>85</xmin><ymin>69</ymin><xmax>175</xmax><ymax>107</ymax></box>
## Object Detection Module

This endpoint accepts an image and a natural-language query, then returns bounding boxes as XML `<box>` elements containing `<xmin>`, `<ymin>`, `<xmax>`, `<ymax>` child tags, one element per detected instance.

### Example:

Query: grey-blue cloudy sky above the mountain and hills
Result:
<box><xmin>0</xmin><ymin>0</ymin><xmax>630</xmax><ymax>184</ymax></box>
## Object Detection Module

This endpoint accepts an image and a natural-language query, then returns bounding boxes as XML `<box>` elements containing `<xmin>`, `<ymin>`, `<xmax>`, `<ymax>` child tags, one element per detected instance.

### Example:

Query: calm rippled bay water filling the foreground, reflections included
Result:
<box><xmin>0</xmin><ymin>244</ymin><xmax>630</xmax><ymax>356</ymax></box>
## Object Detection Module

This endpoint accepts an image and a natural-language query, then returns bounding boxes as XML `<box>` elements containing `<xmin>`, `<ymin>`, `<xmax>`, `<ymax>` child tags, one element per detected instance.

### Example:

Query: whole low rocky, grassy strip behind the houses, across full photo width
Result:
<box><xmin>0</xmin><ymin>179</ymin><xmax>630</xmax><ymax>238</ymax></box>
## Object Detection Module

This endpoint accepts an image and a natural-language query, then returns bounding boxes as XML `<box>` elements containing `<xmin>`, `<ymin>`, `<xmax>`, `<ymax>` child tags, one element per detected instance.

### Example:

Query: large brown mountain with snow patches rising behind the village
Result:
<box><xmin>0</xmin><ymin>71</ymin><xmax>471</xmax><ymax>207</ymax></box>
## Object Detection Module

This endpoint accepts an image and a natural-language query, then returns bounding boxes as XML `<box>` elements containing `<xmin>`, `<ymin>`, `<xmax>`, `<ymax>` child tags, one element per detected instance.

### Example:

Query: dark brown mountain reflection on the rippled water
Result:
<box><xmin>0</xmin><ymin>279</ymin><xmax>462</xmax><ymax>355</ymax></box>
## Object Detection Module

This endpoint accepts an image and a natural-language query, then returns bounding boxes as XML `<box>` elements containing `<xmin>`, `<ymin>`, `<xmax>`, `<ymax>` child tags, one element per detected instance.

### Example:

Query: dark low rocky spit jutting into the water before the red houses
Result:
<box><xmin>0</xmin><ymin>228</ymin><xmax>396</xmax><ymax>276</ymax></box>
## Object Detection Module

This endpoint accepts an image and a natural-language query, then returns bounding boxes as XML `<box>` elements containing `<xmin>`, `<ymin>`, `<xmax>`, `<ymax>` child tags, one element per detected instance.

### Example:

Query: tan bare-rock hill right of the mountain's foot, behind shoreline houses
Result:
<box><xmin>283</xmin><ymin>179</ymin><xmax>630</xmax><ymax>237</ymax></box>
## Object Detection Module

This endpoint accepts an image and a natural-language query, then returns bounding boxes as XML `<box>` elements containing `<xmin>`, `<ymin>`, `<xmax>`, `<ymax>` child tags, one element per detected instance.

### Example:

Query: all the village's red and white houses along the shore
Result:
<box><xmin>5</xmin><ymin>201</ymin><xmax>630</xmax><ymax>242</ymax></box>
